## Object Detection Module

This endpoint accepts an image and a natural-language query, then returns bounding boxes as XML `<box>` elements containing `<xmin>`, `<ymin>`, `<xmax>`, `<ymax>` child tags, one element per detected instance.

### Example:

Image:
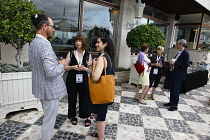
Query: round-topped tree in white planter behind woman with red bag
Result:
<box><xmin>126</xmin><ymin>25</ymin><xmax>165</xmax><ymax>84</ymax></box>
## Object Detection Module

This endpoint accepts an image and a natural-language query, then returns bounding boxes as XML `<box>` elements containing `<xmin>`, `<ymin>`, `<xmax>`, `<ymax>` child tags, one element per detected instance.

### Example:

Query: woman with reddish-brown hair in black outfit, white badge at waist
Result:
<box><xmin>65</xmin><ymin>35</ymin><xmax>92</xmax><ymax>127</ymax></box>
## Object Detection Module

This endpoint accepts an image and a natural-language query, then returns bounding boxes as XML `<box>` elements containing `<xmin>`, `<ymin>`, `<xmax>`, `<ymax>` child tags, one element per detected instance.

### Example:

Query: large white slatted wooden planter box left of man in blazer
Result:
<box><xmin>0</xmin><ymin>72</ymin><xmax>42</xmax><ymax>118</ymax></box>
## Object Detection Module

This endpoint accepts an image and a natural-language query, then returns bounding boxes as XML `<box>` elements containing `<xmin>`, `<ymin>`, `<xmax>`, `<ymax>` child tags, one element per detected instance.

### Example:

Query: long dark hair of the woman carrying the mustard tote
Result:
<box><xmin>98</xmin><ymin>36</ymin><xmax>114</xmax><ymax>62</ymax></box>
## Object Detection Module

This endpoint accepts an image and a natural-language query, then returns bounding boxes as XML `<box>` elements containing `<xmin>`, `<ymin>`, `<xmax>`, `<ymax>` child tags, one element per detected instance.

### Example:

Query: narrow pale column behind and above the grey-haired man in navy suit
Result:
<box><xmin>165</xmin><ymin>14</ymin><xmax>176</xmax><ymax>59</ymax></box>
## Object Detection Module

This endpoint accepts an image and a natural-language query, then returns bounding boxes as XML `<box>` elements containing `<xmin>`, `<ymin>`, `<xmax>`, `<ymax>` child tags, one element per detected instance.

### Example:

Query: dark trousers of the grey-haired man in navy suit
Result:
<box><xmin>170</xmin><ymin>72</ymin><xmax>182</xmax><ymax>107</ymax></box>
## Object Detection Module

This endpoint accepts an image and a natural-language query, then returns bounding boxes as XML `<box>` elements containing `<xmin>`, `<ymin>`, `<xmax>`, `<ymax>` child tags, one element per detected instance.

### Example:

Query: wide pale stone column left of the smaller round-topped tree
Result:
<box><xmin>115</xmin><ymin>0</ymin><xmax>135</xmax><ymax>68</ymax></box>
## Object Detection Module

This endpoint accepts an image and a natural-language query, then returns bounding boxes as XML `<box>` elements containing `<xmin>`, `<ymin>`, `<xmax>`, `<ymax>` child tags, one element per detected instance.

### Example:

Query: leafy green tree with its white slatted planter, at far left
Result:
<box><xmin>0</xmin><ymin>0</ymin><xmax>43</xmax><ymax>118</ymax></box>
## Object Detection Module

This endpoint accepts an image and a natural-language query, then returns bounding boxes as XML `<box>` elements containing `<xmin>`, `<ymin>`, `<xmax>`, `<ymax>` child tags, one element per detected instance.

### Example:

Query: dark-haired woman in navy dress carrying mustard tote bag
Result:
<box><xmin>88</xmin><ymin>36</ymin><xmax>114</xmax><ymax>140</ymax></box>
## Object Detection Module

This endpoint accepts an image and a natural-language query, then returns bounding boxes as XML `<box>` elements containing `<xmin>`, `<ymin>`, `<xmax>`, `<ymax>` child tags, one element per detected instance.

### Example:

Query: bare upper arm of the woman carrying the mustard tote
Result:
<box><xmin>92</xmin><ymin>57</ymin><xmax>107</xmax><ymax>81</ymax></box>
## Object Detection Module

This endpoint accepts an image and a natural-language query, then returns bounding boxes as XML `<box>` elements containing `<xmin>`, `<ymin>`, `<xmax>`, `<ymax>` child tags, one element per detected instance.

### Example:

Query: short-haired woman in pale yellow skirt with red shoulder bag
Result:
<box><xmin>134</xmin><ymin>44</ymin><xmax>151</xmax><ymax>105</ymax></box>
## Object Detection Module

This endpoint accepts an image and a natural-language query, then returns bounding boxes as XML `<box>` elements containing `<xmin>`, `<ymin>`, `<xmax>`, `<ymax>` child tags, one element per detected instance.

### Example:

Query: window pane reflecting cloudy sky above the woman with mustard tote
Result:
<box><xmin>82</xmin><ymin>1</ymin><xmax>114</xmax><ymax>51</ymax></box>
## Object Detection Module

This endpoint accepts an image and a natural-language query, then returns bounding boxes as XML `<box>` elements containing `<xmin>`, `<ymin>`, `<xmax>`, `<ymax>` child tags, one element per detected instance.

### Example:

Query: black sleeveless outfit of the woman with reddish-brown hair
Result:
<box><xmin>66</xmin><ymin>51</ymin><xmax>90</xmax><ymax>119</ymax></box>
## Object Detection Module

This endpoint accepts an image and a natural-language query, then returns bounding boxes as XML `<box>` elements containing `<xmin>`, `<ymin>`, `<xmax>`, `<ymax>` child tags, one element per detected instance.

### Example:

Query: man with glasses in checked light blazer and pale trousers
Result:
<box><xmin>29</xmin><ymin>14</ymin><xmax>67</xmax><ymax>140</ymax></box>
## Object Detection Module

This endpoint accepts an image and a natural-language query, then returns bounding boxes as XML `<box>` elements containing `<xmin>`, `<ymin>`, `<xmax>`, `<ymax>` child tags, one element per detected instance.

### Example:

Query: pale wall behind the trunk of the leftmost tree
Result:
<box><xmin>0</xmin><ymin>43</ymin><xmax>29</xmax><ymax>65</ymax></box>
